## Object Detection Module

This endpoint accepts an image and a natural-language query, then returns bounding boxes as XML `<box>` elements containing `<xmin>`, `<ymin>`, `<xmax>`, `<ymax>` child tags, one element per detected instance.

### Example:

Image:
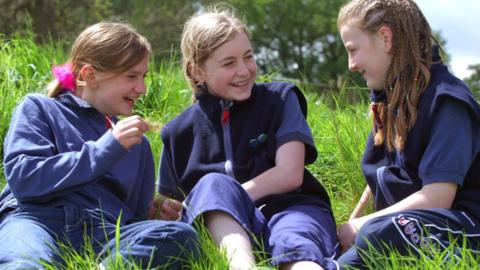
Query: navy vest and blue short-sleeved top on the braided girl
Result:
<box><xmin>362</xmin><ymin>64</ymin><xmax>480</xmax><ymax>221</ymax></box>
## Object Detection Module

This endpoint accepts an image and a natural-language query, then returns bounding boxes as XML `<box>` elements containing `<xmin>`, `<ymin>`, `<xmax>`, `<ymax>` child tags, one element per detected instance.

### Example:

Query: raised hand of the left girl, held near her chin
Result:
<box><xmin>112</xmin><ymin>115</ymin><xmax>149</xmax><ymax>150</ymax></box>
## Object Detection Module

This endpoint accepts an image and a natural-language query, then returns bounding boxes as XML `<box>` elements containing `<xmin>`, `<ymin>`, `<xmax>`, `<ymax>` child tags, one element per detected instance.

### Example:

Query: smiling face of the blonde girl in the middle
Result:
<box><xmin>192</xmin><ymin>32</ymin><xmax>257</xmax><ymax>101</ymax></box>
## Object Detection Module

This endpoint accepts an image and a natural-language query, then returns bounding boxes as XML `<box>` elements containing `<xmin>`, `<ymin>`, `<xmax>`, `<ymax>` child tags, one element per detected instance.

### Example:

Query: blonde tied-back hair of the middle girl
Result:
<box><xmin>181</xmin><ymin>6</ymin><xmax>250</xmax><ymax>95</ymax></box>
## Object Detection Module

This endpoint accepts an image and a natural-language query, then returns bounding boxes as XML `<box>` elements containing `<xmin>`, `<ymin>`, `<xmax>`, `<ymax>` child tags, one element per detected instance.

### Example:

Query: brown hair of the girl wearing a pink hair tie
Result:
<box><xmin>47</xmin><ymin>22</ymin><xmax>152</xmax><ymax>97</ymax></box>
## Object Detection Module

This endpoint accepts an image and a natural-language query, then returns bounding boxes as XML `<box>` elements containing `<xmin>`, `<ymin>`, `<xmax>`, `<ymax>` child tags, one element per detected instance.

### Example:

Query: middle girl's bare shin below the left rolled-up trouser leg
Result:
<box><xmin>204</xmin><ymin>211</ymin><xmax>255</xmax><ymax>270</ymax></box>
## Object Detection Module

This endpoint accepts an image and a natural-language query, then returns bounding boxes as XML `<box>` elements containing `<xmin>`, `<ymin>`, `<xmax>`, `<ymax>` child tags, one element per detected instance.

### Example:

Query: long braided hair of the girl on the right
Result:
<box><xmin>337</xmin><ymin>0</ymin><xmax>434</xmax><ymax>151</ymax></box>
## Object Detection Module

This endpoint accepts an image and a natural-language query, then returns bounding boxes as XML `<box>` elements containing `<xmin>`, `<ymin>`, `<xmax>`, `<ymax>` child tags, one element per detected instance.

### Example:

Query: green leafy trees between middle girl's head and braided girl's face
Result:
<box><xmin>230</xmin><ymin>0</ymin><xmax>349</xmax><ymax>87</ymax></box>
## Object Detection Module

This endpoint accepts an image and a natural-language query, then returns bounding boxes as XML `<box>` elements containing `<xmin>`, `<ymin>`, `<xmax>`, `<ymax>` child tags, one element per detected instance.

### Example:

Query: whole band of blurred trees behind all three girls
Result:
<box><xmin>0</xmin><ymin>0</ymin><xmax>480</xmax><ymax>99</ymax></box>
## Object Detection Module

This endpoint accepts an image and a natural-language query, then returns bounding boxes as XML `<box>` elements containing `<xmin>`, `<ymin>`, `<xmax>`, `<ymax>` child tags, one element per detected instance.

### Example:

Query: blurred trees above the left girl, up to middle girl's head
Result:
<box><xmin>0</xmin><ymin>0</ymin><xmax>213</xmax><ymax>58</ymax></box>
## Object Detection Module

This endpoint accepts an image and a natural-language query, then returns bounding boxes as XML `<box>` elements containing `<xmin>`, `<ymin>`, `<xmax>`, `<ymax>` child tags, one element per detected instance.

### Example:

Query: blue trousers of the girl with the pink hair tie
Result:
<box><xmin>0</xmin><ymin>206</ymin><xmax>198</xmax><ymax>269</ymax></box>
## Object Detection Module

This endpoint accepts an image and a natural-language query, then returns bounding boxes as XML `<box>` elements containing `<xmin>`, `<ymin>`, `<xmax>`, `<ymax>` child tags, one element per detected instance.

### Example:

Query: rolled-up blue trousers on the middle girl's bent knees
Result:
<box><xmin>183</xmin><ymin>173</ymin><xmax>339</xmax><ymax>269</ymax></box>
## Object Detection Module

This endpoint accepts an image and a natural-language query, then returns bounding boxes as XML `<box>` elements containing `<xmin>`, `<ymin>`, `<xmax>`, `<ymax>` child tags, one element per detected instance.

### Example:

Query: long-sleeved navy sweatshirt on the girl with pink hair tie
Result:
<box><xmin>0</xmin><ymin>92</ymin><xmax>155</xmax><ymax>223</ymax></box>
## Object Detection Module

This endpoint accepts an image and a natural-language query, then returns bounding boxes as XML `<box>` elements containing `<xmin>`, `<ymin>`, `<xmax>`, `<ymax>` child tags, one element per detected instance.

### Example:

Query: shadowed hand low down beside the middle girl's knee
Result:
<box><xmin>148</xmin><ymin>194</ymin><xmax>183</xmax><ymax>220</ymax></box>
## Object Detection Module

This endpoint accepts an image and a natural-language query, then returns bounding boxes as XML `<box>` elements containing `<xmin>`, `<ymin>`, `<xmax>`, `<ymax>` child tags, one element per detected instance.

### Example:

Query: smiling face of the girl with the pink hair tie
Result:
<box><xmin>81</xmin><ymin>56</ymin><xmax>148</xmax><ymax>116</ymax></box>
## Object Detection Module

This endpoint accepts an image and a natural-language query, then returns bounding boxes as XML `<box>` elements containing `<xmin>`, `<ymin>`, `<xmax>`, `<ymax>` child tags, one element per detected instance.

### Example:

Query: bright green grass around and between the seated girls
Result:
<box><xmin>0</xmin><ymin>34</ymin><xmax>478</xmax><ymax>270</ymax></box>
